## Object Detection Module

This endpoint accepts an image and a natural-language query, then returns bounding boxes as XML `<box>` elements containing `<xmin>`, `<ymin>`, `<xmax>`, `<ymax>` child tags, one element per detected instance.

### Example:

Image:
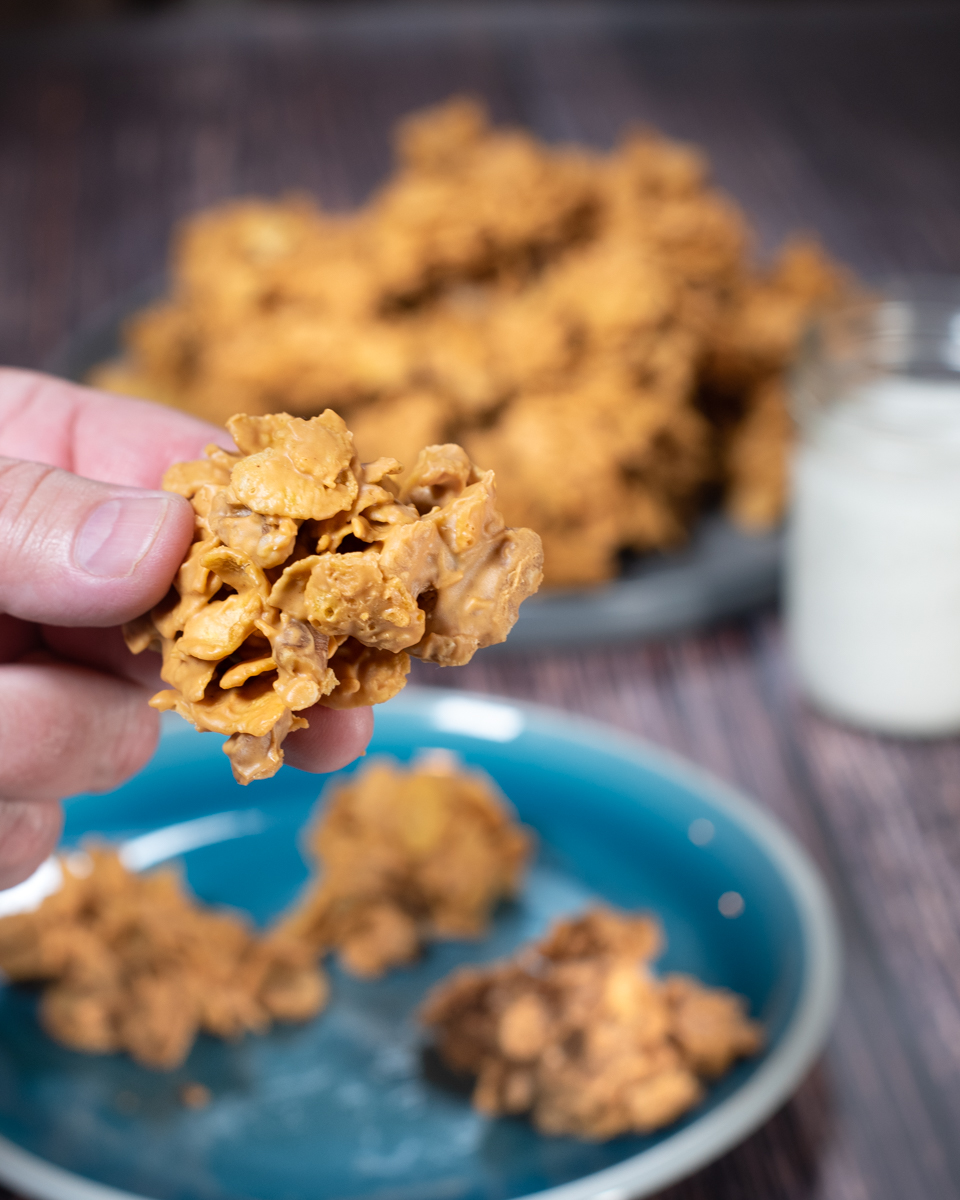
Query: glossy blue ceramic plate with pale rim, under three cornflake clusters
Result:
<box><xmin>0</xmin><ymin>689</ymin><xmax>840</xmax><ymax>1200</ymax></box>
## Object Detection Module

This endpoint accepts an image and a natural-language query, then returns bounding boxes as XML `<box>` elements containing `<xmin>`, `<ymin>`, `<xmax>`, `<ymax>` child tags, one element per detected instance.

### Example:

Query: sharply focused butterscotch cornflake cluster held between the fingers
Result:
<box><xmin>125</xmin><ymin>410</ymin><xmax>542</xmax><ymax>784</ymax></box>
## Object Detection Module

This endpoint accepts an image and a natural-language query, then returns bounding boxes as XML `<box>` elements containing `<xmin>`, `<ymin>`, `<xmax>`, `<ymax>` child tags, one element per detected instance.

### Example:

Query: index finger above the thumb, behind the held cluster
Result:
<box><xmin>0</xmin><ymin>367</ymin><xmax>233</xmax><ymax>488</ymax></box>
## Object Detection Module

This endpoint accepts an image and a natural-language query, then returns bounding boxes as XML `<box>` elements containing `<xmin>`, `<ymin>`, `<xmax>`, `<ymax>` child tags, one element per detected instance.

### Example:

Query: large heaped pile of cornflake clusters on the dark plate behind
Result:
<box><xmin>92</xmin><ymin>100</ymin><xmax>851</xmax><ymax>584</ymax></box>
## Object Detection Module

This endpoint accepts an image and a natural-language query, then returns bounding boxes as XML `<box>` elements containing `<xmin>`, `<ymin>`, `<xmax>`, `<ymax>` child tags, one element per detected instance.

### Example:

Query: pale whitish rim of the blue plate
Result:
<box><xmin>0</xmin><ymin>686</ymin><xmax>842</xmax><ymax>1200</ymax></box>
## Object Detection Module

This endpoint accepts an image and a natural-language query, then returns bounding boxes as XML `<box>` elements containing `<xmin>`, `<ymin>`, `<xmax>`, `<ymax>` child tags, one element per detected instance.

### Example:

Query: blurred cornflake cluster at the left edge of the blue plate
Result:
<box><xmin>0</xmin><ymin>847</ymin><xmax>328</xmax><ymax>1070</ymax></box>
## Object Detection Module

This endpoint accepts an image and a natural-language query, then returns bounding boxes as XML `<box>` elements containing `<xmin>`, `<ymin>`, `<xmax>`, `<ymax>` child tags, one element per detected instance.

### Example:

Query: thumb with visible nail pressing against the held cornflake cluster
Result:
<box><xmin>0</xmin><ymin>458</ymin><xmax>193</xmax><ymax>625</ymax></box>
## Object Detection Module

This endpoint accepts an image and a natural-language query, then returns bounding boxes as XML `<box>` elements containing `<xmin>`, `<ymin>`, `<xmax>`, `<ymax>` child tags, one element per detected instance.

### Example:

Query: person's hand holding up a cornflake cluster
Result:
<box><xmin>0</xmin><ymin>368</ymin><xmax>373</xmax><ymax>888</ymax></box>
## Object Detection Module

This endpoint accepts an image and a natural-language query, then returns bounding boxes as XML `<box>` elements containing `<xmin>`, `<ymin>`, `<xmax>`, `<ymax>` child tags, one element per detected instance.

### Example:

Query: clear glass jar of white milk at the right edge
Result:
<box><xmin>786</xmin><ymin>280</ymin><xmax>960</xmax><ymax>737</ymax></box>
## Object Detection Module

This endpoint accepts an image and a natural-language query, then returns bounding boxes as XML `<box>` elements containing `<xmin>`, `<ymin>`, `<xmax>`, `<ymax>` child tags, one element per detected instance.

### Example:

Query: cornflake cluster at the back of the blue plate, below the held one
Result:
<box><xmin>280</xmin><ymin>752</ymin><xmax>530</xmax><ymax>977</ymax></box>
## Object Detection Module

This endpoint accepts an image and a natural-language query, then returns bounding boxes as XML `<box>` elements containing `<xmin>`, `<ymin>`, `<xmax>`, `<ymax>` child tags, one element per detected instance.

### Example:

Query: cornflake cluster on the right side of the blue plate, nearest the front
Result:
<box><xmin>421</xmin><ymin>908</ymin><xmax>763</xmax><ymax>1141</ymax></box>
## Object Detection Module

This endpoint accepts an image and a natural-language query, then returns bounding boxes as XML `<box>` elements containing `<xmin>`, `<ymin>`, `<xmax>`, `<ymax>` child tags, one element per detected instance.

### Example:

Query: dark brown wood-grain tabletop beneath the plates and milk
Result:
<box><xmin>0</xmin><ymin>4</ymin><xmax>960</xmax><ymax>1200</ymax></box>
